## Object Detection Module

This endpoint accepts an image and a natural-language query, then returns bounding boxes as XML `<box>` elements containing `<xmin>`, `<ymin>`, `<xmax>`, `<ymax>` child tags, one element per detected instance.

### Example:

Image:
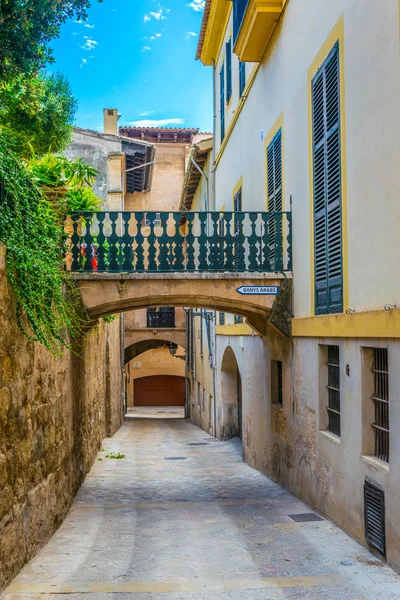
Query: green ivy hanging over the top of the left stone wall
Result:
<box><xmin>0</xmin><ymin>134</ymin><xmax>83</xmax><ymax>355</ymax></box>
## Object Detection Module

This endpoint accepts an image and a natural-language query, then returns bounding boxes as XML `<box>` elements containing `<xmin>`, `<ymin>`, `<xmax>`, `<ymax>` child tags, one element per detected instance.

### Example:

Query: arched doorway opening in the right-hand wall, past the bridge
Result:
<box><xmin>218</xmin><ymin>346</ymin><xmax>242</xmax><ymax>440</ymax></box>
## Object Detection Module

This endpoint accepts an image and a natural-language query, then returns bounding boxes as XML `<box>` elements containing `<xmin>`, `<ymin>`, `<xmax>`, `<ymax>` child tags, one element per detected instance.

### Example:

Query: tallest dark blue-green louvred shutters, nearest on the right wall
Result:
<box><xmin>312</xmin><ymin>43</ymin><xmax>343</xmax><ymax>315</ymax></box>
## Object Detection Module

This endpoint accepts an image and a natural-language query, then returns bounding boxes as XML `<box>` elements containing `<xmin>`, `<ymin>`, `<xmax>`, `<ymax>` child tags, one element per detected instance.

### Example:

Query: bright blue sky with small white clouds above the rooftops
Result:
<box><xmin>51</xmin><ymin>0</ymin><xmax>212</xmax><ymax>131</ymax></box>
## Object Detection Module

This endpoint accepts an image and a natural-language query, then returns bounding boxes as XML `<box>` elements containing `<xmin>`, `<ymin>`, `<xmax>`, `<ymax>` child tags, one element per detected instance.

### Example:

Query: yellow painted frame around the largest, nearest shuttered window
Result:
<box><xmin>308</xmin><ymin>15</ymin><xmax>349</xmax><ymax>315</ymax></box>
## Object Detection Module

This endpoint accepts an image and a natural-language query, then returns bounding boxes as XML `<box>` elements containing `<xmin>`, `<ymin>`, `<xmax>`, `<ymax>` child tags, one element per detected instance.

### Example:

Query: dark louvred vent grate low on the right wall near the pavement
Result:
<box><xmin>364</xmin><ymin>479</ymin><xmax>386</xmax><ymax>556</ymax></box>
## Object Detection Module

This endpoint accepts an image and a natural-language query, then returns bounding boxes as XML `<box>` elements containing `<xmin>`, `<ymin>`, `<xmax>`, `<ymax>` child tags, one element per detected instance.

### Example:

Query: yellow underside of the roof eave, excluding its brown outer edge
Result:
<box><xmin>200</xmin><ymin>0</ymin><xmax>232</xmax><ymax>66</ymax></box>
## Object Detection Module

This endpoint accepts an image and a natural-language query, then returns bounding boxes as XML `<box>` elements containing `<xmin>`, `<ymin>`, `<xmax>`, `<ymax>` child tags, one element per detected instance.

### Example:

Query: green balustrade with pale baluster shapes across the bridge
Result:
<box><xmin>65</xmin><ymin>211</ymin><xmax>292</xmax><ymax>273</ymax></box>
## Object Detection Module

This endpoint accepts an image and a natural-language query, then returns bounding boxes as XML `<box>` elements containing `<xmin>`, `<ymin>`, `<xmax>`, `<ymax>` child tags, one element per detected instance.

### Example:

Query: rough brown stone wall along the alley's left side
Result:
<box><xmin>0</xmin><ymin>245</ymin><xmax>122</xmax><ymax>589</ymax></box>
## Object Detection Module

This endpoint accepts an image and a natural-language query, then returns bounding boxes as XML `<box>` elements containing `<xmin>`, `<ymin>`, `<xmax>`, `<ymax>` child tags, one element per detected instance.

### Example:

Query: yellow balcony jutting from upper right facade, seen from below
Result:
<box><xmin>233</xmin><ymin>0</ymin><xmax>286</xmax><ymax>62</ymax></box>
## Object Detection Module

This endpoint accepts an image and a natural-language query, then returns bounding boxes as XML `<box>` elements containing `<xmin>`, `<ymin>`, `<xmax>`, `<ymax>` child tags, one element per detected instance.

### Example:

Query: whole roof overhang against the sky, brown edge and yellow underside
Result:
<box><xmin>196</xmin><ymin>0</ymin><xmax>232</xmax><ymax>66</ymax></box>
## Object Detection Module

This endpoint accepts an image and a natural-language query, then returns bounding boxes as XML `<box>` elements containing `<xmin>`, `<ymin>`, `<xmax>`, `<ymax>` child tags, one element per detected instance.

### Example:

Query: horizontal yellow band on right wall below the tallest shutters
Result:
<box><xmin>292</xmin><ymin>309</ymin><xmax>400</xmax><ymax>338</ymax></box>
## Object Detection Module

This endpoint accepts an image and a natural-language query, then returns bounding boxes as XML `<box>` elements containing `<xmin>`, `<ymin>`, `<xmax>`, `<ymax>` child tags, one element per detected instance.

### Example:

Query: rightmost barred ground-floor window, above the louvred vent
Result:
<box><xmin>372</xmin><ymin>348</ymin><xmax>389</xmax><ymax>462</ymax></box>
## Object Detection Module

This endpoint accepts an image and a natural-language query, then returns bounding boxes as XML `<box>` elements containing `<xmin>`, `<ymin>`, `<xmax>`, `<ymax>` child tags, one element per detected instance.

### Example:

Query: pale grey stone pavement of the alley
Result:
<box><xmin>1</xmin><ymin>420</ymin><xmax>400</xmax><ymax>600</ymax></box>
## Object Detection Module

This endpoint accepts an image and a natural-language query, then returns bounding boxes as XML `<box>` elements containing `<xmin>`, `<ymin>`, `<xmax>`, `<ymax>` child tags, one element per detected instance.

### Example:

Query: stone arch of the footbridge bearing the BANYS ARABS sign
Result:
<box><xmin>74</xmin><ymin>273</ymin><xmax>290</xmax><ymax>335</ymax></box>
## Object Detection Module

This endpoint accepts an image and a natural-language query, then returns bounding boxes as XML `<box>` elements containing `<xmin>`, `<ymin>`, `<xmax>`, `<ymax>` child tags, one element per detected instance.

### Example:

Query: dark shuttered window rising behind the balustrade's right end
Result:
<box><xmin>267</xmin><ymin>129</ymin><xmax>283</xmax><ymax>269</ymax></box>
